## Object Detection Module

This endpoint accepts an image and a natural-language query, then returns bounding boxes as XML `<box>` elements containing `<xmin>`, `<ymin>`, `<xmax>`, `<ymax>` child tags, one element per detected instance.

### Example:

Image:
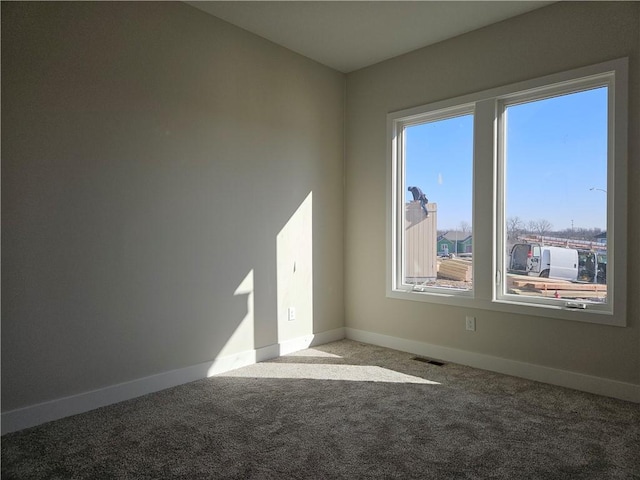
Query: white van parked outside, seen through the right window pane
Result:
<box><xmin>509</xmin><ymin>243</ymin><xmax>579</xmax><ymax>282</ymax></box>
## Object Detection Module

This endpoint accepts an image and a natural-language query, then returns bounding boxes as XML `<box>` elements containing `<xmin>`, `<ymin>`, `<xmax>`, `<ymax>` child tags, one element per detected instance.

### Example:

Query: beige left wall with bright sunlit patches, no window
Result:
<box><xmin>2</xmin><ymin>2</ymin><xmax>345</xmax><ymax>411</ymax></box>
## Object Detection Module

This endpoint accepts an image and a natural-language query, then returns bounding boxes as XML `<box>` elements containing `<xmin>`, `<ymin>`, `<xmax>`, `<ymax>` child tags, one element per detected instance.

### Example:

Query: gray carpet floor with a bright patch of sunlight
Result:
<box><xmin>2</xmin><ymin>340</ymin><xmax>640</xmax><ymax>479</ymax></box>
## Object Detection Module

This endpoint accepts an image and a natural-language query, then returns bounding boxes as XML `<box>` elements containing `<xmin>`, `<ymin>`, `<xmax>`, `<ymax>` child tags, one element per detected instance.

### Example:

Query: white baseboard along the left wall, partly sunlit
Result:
<box><xmin>1</xmin><ymin>328</ymin><xmax>345</xmax><ymax>435</ymax></box>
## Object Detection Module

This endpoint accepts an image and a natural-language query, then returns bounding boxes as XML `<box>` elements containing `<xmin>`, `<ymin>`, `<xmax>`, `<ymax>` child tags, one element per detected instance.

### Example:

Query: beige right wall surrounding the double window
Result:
<box><xmin>345</xmin><ymin>2</ymin><xmax>640</xmax><ymax>384</ymax></box>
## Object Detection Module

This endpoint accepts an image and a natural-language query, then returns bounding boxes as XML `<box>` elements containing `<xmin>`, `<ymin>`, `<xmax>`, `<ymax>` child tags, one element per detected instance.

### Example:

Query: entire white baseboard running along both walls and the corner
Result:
<box><xmin>12</xmin><ymin>328</ymin><xmax>640</xmax><ymax>435</ymax></box>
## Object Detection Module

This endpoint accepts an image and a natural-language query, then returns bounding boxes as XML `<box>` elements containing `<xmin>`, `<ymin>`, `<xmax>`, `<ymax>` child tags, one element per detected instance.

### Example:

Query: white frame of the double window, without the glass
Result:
<box><xmin>386</xmin><ymin>58</ymin><xmax>628</xmax><ymax>326</ymax></box>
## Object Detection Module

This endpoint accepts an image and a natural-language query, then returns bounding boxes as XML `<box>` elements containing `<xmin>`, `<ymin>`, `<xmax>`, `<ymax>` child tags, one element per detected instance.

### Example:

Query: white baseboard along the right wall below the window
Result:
<box><xmin>345</xmin><ymin>328</ymin><xmax>640</xmax><ymax>403</ymax></box>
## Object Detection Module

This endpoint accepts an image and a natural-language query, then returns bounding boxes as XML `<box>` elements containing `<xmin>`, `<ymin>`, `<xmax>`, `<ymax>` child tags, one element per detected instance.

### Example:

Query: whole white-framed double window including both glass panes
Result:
<box><xmin>387</xmin><ymin>59</ymin><xmax>627</xmax><ymax>325</ymax></box>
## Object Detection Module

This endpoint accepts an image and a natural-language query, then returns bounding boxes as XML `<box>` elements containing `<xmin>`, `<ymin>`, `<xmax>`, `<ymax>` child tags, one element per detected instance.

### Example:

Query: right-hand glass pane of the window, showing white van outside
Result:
<box><xmin>504</xmin><ymin>87</ymin><xmax>607</xmax><ymax>303</ymax></box>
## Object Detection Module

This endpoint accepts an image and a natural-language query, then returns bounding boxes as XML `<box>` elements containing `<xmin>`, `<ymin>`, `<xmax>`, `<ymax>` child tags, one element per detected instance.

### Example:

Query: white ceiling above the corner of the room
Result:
<box><xmin>186</xmin><ymin>0</ymin><xmax>553</xmax><ymax>73</ymax></box>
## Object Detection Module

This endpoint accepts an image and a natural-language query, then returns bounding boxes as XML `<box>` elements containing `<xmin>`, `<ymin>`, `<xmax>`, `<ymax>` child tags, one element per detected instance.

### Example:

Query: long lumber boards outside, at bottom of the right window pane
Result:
<box><xmin>507</xmin><ymin>274</ymin><xmax>607</xmax><ymax>298</ymax></box>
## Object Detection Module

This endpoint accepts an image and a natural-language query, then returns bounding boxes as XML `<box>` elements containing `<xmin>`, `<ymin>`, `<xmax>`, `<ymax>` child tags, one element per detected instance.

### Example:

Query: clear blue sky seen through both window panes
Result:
<box><xmin>405</xmin><ymin>87</ymin><xmax>607</xmax><ymax>230</ymax></box>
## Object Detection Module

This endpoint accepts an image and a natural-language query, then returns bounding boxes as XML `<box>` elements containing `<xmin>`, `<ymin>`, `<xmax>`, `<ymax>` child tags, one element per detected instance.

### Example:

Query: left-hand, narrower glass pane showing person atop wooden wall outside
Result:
<box><xmin>402</xmin><ymin>114</ymin><xmax>473</xmax><ymax>290</ymax></box>
